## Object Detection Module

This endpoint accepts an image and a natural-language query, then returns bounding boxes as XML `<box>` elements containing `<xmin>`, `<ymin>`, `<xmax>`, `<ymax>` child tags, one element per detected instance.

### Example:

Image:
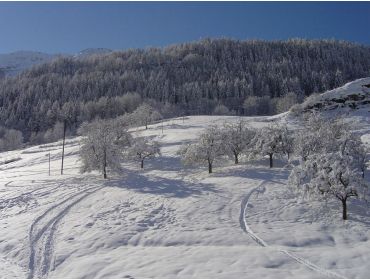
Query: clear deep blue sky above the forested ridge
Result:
<box><xmin>0</xmin><ymin>2</ymin><xmax>370</xmax><ymax>53</ymax></box>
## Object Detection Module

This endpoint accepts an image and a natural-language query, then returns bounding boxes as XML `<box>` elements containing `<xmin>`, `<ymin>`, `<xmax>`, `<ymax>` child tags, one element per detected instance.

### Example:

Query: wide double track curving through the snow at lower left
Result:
<box><xmin>28</xmin><ymin>186</ymin><xmax>103</xmax><ymax>278</ymax></box>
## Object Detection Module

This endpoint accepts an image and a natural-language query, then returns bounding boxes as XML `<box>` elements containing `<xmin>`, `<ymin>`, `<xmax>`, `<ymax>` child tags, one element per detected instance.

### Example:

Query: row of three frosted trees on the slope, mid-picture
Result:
<box><xmin>178</xmin><ymin>120</ymin><xmax>293</xmax><ymax>173</ymax></box>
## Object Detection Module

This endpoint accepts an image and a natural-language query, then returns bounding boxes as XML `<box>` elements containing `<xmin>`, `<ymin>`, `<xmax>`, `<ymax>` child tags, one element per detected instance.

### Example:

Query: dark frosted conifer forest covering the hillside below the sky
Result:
<box><xmin>0</xmin><ymin>39</ymin><xmax>370</xmax><ymax>140</ymax></box>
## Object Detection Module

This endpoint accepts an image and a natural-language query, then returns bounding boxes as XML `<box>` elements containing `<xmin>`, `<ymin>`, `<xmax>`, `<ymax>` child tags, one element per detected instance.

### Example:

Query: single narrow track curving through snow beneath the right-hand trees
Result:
<box><xmin>239</xmin><ymin>181</ymin><xmax>346</xmax><ymax>279</ymax></box>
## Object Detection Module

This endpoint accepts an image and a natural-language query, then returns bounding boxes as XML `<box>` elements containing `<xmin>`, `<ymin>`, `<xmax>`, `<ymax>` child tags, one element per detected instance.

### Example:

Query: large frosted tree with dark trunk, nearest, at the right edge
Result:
<box><xmin>289</xmin><ymin>133</ymin><xmax>369</xmax><ymax>220</ymax></box>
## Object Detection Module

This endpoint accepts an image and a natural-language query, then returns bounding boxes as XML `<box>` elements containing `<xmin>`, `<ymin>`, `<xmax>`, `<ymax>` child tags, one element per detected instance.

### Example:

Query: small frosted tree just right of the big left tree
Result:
<box><xmin>127</xmin><ymin>137</ymin><xmax>160</xmax><ymax>168</ymax></box>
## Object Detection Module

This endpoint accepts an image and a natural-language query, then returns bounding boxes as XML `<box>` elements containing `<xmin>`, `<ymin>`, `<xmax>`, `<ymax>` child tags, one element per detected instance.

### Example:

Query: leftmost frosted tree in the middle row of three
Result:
<box><xmin>178</xmin><ymin>126</ymin><xmax>224</xmax><ymax>173</ymax></box>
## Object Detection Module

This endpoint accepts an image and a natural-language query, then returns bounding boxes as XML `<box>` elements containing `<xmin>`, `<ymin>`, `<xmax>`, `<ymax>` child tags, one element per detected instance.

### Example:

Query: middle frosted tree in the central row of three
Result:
<box><xmin>221</xmin><ymin>120</ymin><xmax>256</xmax><ymax>164</ymax></box>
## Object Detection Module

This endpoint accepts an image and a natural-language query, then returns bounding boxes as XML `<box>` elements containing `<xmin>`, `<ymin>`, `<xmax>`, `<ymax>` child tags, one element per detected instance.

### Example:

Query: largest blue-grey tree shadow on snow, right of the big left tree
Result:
<box><xmin>106</xmin><ymin>170</ymin><xmax>217</xmax><ymax>198</ymax></box>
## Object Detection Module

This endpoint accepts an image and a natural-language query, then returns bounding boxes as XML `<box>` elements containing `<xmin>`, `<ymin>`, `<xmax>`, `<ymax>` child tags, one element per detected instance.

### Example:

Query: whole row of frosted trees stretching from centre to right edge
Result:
<box><xmin>178</xmin><ymin>114</ymin><xmax>369</xmax><ymax>219</ymax></box>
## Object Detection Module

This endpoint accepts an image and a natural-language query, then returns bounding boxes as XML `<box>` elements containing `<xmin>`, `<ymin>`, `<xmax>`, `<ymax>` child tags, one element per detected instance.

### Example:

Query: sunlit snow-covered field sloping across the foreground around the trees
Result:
<box><xmin>0</xmin><ymin>114</ymin><xmax>370</xmax><ymax>278</ymax></box>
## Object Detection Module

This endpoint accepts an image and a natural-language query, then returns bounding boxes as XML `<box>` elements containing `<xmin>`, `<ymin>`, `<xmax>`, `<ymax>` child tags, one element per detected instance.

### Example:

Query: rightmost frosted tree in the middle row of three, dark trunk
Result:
<box><xmin>256</xmin><ymin>124</ymin><xmax>284</xmax><ymax>168</ymax></box>
